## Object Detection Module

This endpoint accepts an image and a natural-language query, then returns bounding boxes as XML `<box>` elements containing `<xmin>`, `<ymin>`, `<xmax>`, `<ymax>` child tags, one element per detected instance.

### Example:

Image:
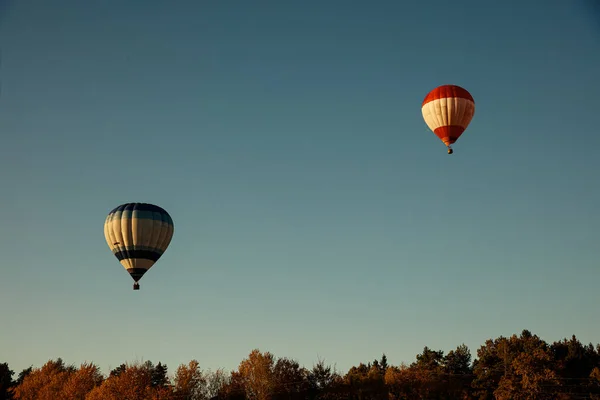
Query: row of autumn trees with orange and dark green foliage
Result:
<box><xmin>0</xmin><ymin>330</ymin><xmax>600</xmax><ymax>400</ymax></box>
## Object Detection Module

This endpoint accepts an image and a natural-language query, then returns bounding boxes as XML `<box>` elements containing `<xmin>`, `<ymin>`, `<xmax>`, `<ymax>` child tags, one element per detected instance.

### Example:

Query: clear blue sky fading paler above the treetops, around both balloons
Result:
<box><xmin>0</xmin><ymin>0</ymin><xmax>600</xmax><ymax>372</ymax></box>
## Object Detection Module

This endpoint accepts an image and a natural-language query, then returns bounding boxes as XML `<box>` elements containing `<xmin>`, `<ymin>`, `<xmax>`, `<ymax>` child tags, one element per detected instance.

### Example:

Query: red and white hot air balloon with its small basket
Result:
<box><xmin>421</xmin><ymin>85</ymin><xmax>475</xmax><ymax>154</ymax></box>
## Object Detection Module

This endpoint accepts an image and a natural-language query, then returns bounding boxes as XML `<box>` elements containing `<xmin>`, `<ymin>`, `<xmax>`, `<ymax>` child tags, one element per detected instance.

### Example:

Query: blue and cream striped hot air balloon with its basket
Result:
<box><xmin>104</xmin><ymin>203</ymin><xmax>174</xmax><ymax>290</ymax></box>
